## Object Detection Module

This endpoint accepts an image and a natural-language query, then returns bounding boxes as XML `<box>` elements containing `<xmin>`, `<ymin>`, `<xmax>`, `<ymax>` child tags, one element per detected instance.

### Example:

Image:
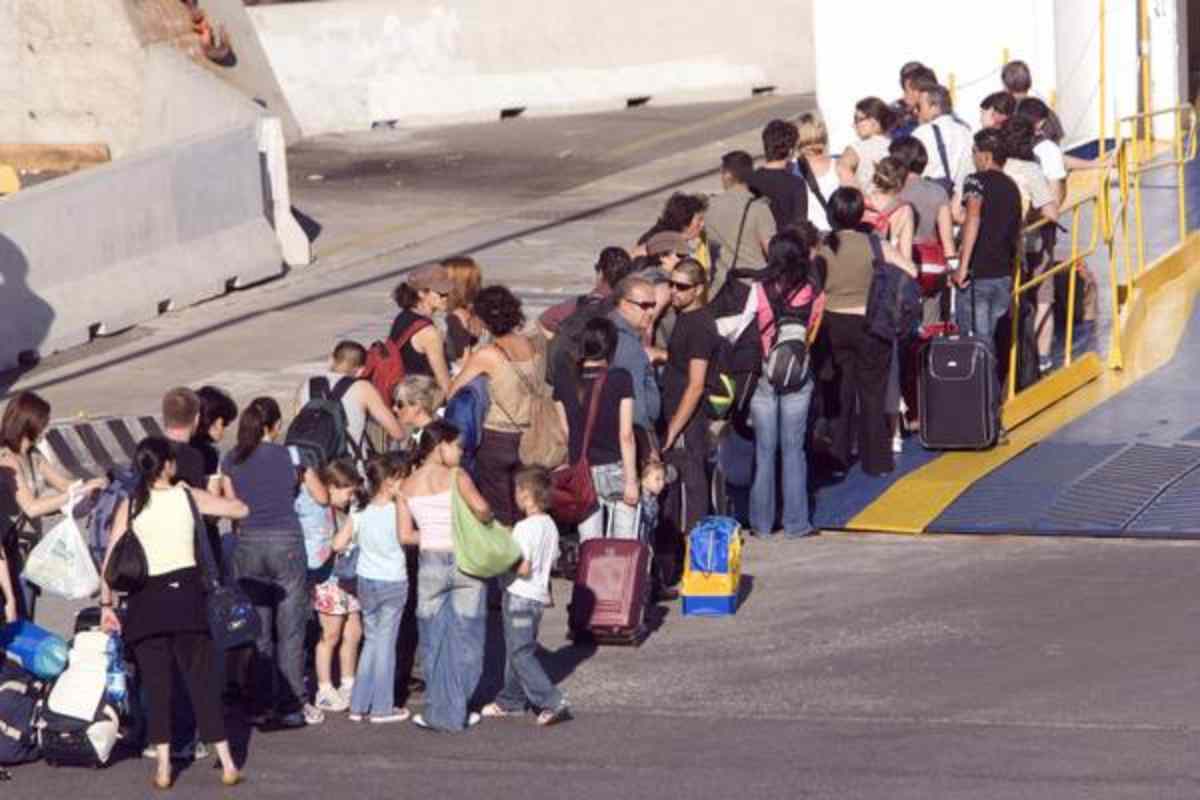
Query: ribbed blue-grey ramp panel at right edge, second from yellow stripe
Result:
<box><xmin>1037</xmin><ymin>444</ymin><xmax>1200</xmax><ymax>535</ymax></box>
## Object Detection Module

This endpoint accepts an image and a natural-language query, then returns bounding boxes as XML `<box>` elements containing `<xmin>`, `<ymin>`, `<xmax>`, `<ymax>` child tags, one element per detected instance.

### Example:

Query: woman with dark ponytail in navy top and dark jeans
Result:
<box><xmin>222</xmin><ymin>397</ymin><xmax>329</xmax><ymax>728</ymax></box>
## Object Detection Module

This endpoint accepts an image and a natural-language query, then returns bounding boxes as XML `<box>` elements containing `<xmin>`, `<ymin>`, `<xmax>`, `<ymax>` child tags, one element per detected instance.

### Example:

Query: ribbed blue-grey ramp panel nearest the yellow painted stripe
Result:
<box><xmin>929</xmin><ymin>441</ymin><xmax>1124</xmax><ymax>534</ymax></box>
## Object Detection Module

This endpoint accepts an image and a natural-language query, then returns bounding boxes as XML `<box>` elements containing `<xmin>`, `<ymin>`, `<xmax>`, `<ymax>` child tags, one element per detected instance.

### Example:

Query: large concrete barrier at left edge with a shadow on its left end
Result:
<box><xmin>0</xmin><ymin>121</ymin><xmax>282</xmax><ymax>367</ymax></box>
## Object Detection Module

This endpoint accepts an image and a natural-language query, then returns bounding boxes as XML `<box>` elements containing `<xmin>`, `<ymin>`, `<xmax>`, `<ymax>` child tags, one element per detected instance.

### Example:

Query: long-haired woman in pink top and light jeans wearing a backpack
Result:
<box><xmin>750</xmin><ymin>230</ymin><xmax>824</xmax><ymax>539</ymax></box>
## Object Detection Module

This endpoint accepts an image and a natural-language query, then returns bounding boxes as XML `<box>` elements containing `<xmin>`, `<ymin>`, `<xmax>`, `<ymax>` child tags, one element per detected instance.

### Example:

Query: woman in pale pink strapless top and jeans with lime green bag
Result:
<box><xmin>400</xmin><ymin>420</ymin><xmax>492</xmax><ymax>730</ymax></box>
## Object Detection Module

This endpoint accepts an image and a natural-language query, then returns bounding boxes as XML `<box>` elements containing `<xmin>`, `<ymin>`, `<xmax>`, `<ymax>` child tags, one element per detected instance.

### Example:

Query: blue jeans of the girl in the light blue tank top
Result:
<box><xmin>350</xmin><ymin>577</ymin><xmax>408</xmax><ymax>716</ymax></box>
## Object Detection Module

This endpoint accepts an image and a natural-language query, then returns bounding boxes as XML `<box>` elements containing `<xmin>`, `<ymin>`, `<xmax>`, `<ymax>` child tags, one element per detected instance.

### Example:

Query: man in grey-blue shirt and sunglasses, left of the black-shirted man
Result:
<box><xmin>608</xmin><ymin>276</ymin><xmax>662</xmax><ymax>460</ymax></box>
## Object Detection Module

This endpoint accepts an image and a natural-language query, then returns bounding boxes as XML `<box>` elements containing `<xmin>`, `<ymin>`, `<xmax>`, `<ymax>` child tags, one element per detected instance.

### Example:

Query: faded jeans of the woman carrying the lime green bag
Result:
<box><xmin>416</xmin><ymin>551</ymin><xmax>487</xmax><ymax>730</ymax></box>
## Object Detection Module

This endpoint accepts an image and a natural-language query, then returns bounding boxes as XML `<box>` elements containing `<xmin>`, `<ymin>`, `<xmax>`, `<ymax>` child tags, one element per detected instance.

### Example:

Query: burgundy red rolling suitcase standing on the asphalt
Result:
<box><xmin>566</xmin><ymin>515</ymin><xmax>650</xmax><ymax>644</ymax></box>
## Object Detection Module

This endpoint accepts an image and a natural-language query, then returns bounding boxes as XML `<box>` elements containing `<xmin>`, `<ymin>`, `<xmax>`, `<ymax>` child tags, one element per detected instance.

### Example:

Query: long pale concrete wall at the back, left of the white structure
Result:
<box><xmin>247</xmin><ymin>0</ymin><xmax>814</xmax><ymax>136</ymax></box>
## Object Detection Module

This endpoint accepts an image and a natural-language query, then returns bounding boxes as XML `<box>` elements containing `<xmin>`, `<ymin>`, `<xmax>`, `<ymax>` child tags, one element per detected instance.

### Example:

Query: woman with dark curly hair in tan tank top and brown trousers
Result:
<box><xmin>449</xmin><ymin>287</ymin><xmax>546</xmax><ymax>525</ymax></box>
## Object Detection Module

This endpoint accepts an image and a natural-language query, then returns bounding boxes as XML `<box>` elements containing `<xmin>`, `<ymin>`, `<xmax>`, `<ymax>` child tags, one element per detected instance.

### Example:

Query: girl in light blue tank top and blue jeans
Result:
<box><xmin>334</xmin><ymin>455</ymin><xmax>416</xmax><ymax>723</ymax></box>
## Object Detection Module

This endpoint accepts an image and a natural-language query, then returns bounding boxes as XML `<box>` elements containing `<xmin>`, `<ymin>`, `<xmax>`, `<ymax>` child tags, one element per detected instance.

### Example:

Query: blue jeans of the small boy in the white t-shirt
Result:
<box><xmin>496</xmin><ymin>593</ymin><xmax>565</xmax><ymax>711</ymax></box>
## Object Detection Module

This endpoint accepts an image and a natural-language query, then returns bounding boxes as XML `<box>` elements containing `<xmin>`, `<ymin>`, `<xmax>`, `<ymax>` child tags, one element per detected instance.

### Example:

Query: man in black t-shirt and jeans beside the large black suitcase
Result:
<box><xmin>954</xmin><ymin>128</ymin><xmax>1021</xmax><ymax>342</ymax></box>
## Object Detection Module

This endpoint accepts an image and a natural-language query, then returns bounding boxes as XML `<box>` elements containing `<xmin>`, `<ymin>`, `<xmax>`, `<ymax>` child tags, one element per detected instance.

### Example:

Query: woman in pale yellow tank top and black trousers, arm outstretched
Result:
<box><xmin>100</xmin><ymin>437</ymin><xmax>248</xmax><ymax>789</ymax></box>
